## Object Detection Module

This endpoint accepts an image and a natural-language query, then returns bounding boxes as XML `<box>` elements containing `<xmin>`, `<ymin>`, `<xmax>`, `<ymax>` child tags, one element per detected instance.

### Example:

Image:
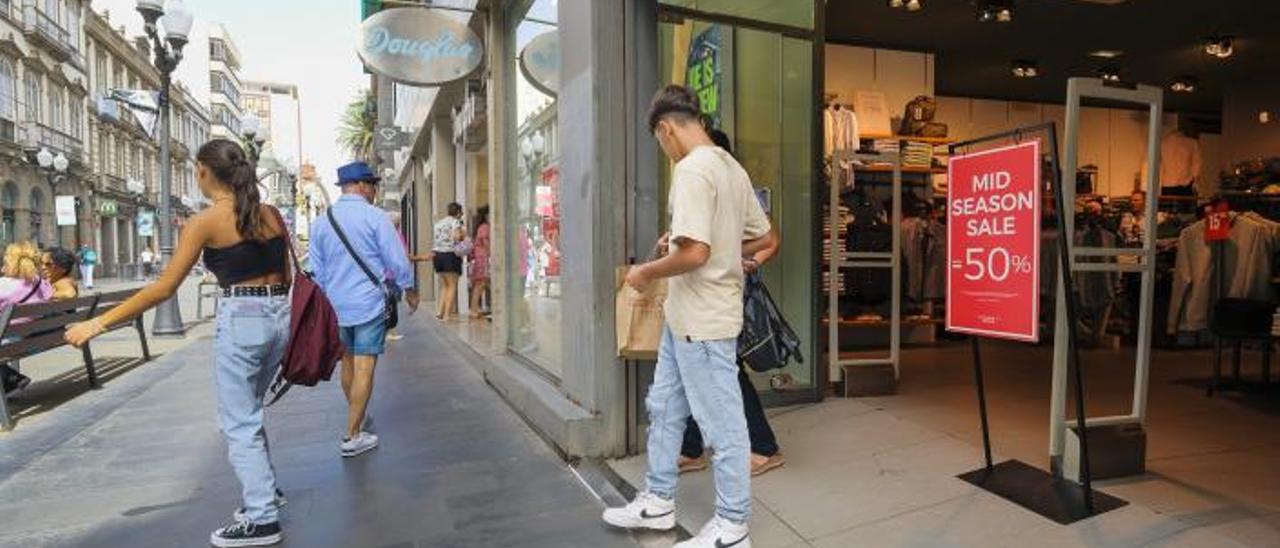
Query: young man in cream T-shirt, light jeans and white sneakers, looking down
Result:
<box><xmin>604</xmin><ymin>86</ymin><xmax>776</xmax><ymax>548</ymax></box>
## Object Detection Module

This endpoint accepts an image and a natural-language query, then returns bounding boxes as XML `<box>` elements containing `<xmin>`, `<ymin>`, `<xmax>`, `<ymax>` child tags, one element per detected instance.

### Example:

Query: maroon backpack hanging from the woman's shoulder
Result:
<box><xmin>268</xmin><ymin>207</ymin><xmax>343</xmax><ymax>405</ymax></box>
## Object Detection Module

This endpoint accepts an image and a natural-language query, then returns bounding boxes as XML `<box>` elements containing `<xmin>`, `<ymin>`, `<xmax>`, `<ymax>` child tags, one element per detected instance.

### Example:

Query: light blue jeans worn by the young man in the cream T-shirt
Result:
<box><xmin>645</xmin><ymin>322</ymin><xmax>751</xmax><ymax>524</ymax></box>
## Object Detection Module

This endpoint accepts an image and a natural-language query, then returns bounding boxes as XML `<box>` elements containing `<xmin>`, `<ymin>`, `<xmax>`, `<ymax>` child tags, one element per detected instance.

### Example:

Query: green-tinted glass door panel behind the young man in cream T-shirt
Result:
<box><xmin>658</xmin><ymin>13</ymin><xmax>822</xmax><ymax>405</ymax></box>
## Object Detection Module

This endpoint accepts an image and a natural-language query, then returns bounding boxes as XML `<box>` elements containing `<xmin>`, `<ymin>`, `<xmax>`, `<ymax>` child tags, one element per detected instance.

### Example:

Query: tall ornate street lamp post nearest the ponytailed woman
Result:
<box><xmin>137</xmin><ymin>0</ymin><xmax>192</xmax><ymax>337</ymax></box>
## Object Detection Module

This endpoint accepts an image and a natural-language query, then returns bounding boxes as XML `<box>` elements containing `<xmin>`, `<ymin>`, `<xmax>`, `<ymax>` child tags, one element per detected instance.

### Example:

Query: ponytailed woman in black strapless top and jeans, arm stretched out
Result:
<box><xmin>67</xmin><ymin>138</ymin><xmax>291</xmax><ymax>547</ymax></box>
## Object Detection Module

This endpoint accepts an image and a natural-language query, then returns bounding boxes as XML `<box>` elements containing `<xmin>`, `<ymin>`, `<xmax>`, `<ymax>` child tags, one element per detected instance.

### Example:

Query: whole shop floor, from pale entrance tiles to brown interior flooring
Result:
<box><xmin>611</xmin><ymin>342</ymin><xmax>1280</xmax><ymax>548</ymax></box>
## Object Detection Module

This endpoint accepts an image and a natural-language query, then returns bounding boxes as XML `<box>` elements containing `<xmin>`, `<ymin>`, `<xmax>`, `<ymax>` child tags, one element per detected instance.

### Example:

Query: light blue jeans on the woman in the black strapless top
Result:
<box><xmin>214</xmin><ymin>296</ymin><xmax>289</xmax><ymax>524</ymax></box>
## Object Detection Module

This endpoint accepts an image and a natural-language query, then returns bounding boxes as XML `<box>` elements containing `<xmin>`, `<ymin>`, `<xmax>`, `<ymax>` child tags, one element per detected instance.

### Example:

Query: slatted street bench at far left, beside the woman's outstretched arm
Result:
<box><xmin>0</xmin><ymin>289</ymin><xmax>151</xmax><ymax>430</ymax></box>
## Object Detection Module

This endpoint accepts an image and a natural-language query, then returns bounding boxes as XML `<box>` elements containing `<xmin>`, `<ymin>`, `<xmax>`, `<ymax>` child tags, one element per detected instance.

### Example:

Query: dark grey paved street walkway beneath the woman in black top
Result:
<box><xmin>0</xmin><ymin>309</ymin><xmax>635</xmax><ymax>548</ymax></box>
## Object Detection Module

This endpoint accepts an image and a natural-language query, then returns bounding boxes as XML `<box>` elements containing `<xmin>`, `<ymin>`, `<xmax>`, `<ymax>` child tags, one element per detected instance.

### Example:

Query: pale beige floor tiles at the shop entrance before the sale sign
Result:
<box><xmin>609</xmin><ymin>399</ymin><xmax>1280</xmax><ymax>548</ymax></box>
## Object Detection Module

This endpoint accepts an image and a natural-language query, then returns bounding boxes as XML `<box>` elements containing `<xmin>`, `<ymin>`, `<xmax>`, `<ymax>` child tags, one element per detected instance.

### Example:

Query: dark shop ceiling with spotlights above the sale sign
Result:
<box><xmin>827</xmin><ymin>0</ymin><xmax>1280</xmax><ymax>114</ymax></box>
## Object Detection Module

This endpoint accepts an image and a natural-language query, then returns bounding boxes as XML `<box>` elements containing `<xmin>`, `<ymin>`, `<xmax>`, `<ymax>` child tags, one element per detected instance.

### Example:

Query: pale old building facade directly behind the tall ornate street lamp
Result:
<box><xmin>84</xmin><ymin>4</ymin><xmax>210</xmax><ymax>277</ymax></box>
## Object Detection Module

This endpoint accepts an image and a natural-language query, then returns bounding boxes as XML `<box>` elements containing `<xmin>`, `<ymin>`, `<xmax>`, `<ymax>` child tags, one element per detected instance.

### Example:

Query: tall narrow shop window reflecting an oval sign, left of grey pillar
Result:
<box><xmin>507</xmin><ymin>0</ymin><xmax>566</xmax><ymax>378</ymax></box>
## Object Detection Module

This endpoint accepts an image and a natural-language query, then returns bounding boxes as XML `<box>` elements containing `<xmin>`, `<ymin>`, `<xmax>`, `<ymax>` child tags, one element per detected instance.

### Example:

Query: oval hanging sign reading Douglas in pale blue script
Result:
<box><xmin>356</xmin><ymin>8</ymin><xmax>484</xmax><ymax>86</ymax></box>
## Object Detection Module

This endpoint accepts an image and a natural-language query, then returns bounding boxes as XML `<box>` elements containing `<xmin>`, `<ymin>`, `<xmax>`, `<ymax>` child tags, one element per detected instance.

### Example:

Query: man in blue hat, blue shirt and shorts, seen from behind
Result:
<box><xmin>311</xmin><ymin>161</ymin><xmax>417</xmax><ymax>457</ymax></box>
